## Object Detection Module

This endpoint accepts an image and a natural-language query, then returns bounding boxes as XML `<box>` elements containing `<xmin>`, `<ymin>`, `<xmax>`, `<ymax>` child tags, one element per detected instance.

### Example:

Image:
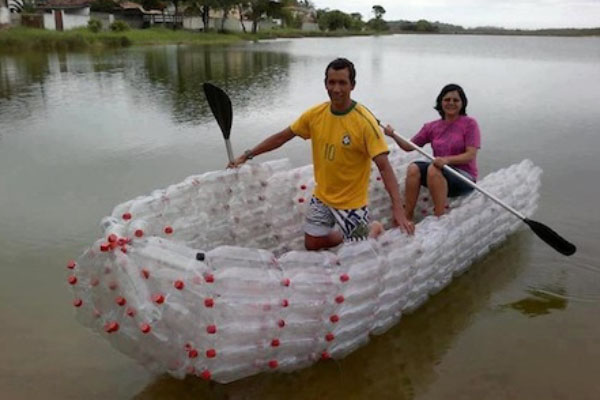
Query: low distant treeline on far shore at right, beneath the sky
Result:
<box><xmin>387</xmin><ymin>19</ymin><xmax>600</xmax><ymax>36</ymax></box>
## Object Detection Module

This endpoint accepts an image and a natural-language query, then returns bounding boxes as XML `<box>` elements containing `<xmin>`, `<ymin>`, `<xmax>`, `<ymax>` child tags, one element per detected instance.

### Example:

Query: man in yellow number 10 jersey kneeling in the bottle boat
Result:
<box><xmin>230</xmin><ymin>58</ymin><xmax>415</xmax><ymax>250</ymax></box>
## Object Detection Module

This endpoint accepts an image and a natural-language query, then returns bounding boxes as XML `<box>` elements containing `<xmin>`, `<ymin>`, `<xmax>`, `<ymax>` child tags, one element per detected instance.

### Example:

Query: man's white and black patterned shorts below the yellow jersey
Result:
<box><xmin>304</xmin><ymin>195</ymin><xmax>369</xmax><ymax>241</ymax></box>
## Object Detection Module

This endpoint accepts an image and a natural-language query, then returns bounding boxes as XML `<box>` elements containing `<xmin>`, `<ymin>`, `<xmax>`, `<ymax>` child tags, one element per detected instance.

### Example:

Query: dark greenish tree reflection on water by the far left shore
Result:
<box><xmin>0</xmin><ymin>46</ymin><xmax>290</xmax><ymax>123</ymax></box>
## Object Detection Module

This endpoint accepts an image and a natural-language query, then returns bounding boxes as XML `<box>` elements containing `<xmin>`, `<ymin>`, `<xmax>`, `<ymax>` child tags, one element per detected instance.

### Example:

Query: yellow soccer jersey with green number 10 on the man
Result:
<box><xmin>290</xmin><ymin>102</ymin><xmax>388</xmax><ymax>209</ymax></box>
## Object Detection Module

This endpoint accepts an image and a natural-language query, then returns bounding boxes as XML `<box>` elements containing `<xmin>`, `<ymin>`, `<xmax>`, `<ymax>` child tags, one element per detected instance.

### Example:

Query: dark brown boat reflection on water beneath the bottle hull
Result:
<box><xmin>135</xmin><ymin>232</ymin><xmax>529</xmax><ymax>400</ymax></box>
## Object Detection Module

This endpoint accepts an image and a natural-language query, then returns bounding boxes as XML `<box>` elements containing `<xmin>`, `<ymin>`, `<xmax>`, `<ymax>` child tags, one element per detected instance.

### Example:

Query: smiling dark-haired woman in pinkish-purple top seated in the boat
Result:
<box><xmin>384</xmin><ymin>84</ymin><xmax>481</xmax><ymax>220</ymax></box>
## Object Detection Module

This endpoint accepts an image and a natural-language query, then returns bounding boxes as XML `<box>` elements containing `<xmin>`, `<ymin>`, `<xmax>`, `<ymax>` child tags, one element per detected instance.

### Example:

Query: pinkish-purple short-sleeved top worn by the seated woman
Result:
<box><xmin>411</xmin><ymin>115</ymin><xmax>481</xmax><ymax>179</ymax></box>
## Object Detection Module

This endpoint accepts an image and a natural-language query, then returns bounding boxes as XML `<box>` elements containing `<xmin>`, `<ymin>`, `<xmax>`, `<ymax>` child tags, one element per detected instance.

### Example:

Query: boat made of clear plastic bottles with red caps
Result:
<box><xmin>67</xmin><ymin>151</ymin><xmax>541</xmax><ymax>382</ymax></box>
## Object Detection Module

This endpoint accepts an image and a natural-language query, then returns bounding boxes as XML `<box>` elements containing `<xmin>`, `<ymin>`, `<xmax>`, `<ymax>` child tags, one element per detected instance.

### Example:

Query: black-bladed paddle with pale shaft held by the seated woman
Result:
<box><xmin>379</xmin><ymin>122</ymin><xmax>577</xmax><ymax>256</ymax></box>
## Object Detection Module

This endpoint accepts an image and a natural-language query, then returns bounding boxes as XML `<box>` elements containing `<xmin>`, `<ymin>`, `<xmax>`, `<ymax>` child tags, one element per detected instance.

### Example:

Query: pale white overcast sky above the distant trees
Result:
<box><xmin>311</xmin><ymin>0</ymin><xmax>600</xmax><ymax>29</ymax></box>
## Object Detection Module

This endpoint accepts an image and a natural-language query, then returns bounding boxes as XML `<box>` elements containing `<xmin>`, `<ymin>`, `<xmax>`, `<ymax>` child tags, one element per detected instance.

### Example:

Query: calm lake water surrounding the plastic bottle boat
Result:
<box><xmin>0</xmin><ymin>35</ymin><xmax>600</xmax><ymax>399</ymax></box>
